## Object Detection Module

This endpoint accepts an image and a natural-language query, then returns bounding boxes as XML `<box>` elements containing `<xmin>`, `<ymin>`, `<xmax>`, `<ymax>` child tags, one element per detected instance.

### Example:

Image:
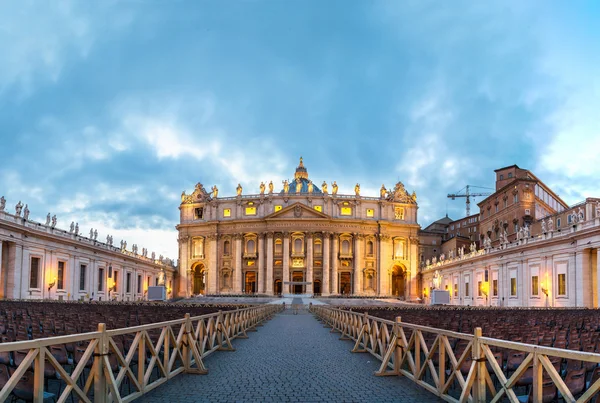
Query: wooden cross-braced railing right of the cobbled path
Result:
<box><xmin>310</xmin><ymin>306</ymin><xmax>600</xmax><ymax>403</ymax></box>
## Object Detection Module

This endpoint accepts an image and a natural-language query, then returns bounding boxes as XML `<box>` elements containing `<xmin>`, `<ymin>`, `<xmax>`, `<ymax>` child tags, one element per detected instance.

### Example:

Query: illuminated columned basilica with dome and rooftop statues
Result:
<box><xmin>177</xmin><ymin>159</ymin><xmax>419</xmax><ymax>300</ymax></box>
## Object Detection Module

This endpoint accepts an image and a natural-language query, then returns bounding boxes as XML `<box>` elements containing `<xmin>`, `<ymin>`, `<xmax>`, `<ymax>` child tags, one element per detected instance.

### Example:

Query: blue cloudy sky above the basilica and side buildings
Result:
<box><xmin>0</xmin><ymin>0</ymin><xmax>600</xmax><ymax>257</ymax></box>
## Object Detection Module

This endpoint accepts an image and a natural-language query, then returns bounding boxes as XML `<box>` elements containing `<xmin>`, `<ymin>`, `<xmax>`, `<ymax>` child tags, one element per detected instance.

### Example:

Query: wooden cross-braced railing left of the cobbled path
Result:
<box><xmin>0</xmin><ymin>305</ymin><xmax>282</xmax><ymax>403</ymax></box>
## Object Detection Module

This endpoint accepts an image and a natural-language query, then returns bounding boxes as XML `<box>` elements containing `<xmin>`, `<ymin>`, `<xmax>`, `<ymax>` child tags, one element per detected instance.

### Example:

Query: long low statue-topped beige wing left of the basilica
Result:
<box><xmin>0</xmin><ymin>197</ymin><xmax>176</xmax><ymax>301</ymax></box>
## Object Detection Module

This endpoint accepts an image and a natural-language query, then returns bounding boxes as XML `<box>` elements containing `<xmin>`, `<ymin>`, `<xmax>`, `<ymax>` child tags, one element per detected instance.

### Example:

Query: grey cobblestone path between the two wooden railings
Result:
<box><xmin>137</xmin><ymin>310</ymin><xmax>440</xmax><ymax>403</ymax></box>
